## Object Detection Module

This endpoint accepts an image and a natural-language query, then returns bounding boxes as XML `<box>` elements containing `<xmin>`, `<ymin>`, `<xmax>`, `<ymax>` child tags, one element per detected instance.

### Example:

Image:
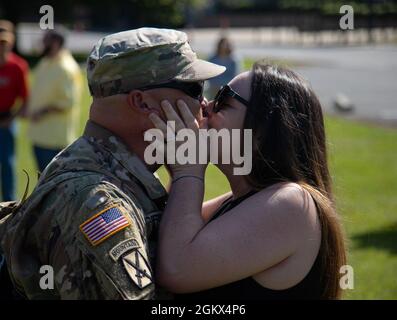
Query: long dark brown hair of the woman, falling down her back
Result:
<box><xmin>244</xmin><ymin>62</ymin><xmax>346</xmax><ymax>299</ymax></box>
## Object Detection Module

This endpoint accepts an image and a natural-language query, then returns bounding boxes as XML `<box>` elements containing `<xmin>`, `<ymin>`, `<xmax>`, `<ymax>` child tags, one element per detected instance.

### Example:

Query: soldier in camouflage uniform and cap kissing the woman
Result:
<box><xmin>0</xmin><ymin>28</ymin><xmax>225</xmax><ymax>299</ymax></box>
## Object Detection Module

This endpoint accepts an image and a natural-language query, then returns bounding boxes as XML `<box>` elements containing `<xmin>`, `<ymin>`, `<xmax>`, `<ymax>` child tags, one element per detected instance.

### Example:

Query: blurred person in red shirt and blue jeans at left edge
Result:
<box><xmin>0</xmin><ymin>20</ymin><xmax>29</xmax><ymax>201</ymax></box>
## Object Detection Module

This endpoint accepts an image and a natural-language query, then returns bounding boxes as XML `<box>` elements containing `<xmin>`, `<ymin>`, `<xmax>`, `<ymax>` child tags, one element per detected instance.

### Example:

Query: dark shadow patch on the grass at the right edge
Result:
<box><xmin>352</xmin><ymin>223</ymin><xmax>397</xmax><ymax>254</ymax></box>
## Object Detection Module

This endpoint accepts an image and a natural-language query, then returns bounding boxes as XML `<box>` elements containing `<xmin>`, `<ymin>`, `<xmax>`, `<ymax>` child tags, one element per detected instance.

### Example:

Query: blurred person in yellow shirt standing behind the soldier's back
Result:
<box><xmin>28</xmin><ymin>31</ymin><xmax>82</xmax><ymax>172</ymax></box>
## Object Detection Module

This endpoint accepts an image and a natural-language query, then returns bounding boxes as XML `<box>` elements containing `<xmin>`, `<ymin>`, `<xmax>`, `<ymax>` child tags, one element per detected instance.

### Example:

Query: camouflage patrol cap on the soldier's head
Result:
<box><xmin>87</xmin><ymin>28</ymin><xmax>226</xmax><ymax>97</ymax></box>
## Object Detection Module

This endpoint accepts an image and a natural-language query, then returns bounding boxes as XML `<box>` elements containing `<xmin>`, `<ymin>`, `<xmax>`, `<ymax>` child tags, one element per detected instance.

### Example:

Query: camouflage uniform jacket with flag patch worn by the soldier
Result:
<box><xmin>0</xmin><ymin>121</ymin><xmax>166</xmax><ymax>299</ymax></box>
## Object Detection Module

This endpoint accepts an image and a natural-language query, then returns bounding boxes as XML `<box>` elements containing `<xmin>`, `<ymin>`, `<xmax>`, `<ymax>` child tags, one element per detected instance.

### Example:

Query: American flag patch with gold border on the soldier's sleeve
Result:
<box><xmin>80</xmin><ymin>205</ymin><xmax>131</xmax><ymax>246</ymax></box>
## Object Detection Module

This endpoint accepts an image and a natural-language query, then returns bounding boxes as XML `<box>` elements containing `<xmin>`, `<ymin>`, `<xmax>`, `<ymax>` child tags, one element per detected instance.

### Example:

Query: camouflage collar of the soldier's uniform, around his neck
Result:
<box><xmin>83</xmin><ymin>120</ymin><xmax>166</xmax><ymax>199</ymax></box>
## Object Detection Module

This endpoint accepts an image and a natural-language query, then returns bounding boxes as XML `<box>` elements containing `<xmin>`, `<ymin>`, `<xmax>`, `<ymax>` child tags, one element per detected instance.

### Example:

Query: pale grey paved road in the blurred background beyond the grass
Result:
<box><xmin>19</xmin><ymin>24</ymin><xmax>397</xmax><ymax>125</ymax></box>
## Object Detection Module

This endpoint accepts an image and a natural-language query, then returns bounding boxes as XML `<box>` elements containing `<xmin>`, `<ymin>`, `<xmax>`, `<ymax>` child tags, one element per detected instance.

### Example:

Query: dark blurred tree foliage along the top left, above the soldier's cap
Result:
<box><xmin>0</xmin><ymin>0</ymin><xmax>209</xmax><ymax>30</ymax></box>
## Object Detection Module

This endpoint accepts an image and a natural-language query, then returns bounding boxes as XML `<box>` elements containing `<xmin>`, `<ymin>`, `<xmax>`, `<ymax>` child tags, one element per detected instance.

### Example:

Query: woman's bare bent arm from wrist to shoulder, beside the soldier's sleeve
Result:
<box><xmin>157</xmin><ymin>178</ymin><xmax>315</xmax><ymax>293</ymax></box>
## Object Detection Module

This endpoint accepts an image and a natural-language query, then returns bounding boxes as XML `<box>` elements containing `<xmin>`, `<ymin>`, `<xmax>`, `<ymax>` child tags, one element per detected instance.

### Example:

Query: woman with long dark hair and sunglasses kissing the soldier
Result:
<box><xmin>150</xmin><ymin>63</ymin><xmax>345</xmax><ymax>300</ymax></box>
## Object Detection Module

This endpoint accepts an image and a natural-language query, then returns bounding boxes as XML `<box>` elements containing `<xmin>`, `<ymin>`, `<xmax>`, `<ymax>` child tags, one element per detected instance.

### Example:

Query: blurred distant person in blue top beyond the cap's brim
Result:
<box><xmin>208</xmin><ymin>37</ymin><xmax>240</xmax><ymax>99</ymax></box>
